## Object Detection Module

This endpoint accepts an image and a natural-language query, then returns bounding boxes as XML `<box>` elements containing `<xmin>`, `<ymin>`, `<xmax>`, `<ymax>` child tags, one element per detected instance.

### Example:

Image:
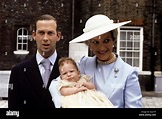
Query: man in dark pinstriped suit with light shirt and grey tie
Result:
<box><xmin>8</xmin><ymin>14</ymin><xmax>61</xmax><ymax>108</ymax></box>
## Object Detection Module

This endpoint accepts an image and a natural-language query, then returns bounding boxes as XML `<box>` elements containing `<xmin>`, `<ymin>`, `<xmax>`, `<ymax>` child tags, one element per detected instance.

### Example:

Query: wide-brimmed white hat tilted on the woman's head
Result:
<box><xmin>69</xmin><ymin>14</ymin><xmax>131</xmax><ymax>43</ymax></box>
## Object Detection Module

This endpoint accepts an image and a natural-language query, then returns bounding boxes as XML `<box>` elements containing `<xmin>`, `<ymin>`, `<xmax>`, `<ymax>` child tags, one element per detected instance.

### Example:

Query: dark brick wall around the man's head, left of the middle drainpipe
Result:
<box><xmin>0</xmin><ymin>0</ymin><xmax>72</xmax><ymax>70</ymax></box>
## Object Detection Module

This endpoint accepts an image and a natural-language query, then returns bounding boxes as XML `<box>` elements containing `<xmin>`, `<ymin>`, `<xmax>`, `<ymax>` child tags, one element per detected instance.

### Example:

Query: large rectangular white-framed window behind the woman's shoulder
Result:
<box><xmin>117</xmin><ymin>27</ymin><xmax>143</xmax><ymax>71</ymax></box>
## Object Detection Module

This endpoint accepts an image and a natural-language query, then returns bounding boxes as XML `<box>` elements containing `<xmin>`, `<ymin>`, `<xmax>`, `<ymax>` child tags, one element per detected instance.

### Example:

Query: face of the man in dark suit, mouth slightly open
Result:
<box><xmin>33</xmin><ymin>20</ymin><xmax>61</xmax><ymax>58</ymax></box>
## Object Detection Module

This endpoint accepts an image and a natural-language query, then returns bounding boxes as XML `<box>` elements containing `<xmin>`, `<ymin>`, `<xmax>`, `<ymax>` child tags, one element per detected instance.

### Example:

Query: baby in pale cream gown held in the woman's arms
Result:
<box><xmin>58</xmin><ymin>57</ymin><xmax>114</xmax><ymax>108</ymax></box>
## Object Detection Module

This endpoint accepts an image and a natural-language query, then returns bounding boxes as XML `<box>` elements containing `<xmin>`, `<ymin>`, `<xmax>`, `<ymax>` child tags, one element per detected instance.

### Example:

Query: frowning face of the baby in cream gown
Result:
<box><xmin>60</xmin><ymin>63</ymin><xmax>80</xmax><ymax>82</ymax></box>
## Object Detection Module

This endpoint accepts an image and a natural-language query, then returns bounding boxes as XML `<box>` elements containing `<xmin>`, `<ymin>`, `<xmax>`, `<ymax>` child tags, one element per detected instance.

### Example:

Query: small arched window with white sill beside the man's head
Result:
<box><xmin>14</xmin><ymin>27</ymin><xmax>29</xmax><ymax>54</ymax></box>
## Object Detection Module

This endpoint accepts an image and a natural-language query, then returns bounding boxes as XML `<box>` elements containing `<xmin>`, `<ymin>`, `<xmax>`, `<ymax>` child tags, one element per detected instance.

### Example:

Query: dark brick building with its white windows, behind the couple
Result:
<box><xmin>0</xmin><ymin>0</ymin><xmax>162</xmax><ymax>90</ymax></box>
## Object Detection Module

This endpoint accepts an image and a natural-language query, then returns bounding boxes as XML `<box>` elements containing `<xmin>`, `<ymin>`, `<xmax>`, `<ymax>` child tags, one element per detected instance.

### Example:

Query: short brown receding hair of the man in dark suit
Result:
<box><xmin>34</xmin><ymin>14</ymin><xmax>57</xmax><ymax>31</ymax></box>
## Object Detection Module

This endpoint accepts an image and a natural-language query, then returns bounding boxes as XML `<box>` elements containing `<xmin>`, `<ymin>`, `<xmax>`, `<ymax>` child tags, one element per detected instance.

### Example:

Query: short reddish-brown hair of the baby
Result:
<box><xmin>58</xmin><ymin>57</ymin><xmax>79</xmax><ymax>71</ymax></box>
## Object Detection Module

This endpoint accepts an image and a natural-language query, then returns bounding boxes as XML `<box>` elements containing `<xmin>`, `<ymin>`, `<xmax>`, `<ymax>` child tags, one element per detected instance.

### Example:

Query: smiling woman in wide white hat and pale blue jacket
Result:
<box><xmin>70</xmin><ymin>14</ymin><xmax>142</xmax><ymax>108</ymax></box>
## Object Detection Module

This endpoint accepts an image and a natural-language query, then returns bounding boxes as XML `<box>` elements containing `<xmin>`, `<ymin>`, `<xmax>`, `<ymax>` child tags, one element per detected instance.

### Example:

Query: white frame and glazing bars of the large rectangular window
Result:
<box><xmin>117</xmin><ymin>26</ymin><xmax>143</xmax><ymax>71</ymax></box>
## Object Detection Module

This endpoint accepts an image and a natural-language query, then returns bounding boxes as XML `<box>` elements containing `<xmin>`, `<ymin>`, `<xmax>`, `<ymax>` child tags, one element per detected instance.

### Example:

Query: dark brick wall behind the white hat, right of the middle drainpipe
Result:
<box><xmin>75</xmin><ymin>0</ymin><xmax>162</xmax><ymax>71</ymax></box>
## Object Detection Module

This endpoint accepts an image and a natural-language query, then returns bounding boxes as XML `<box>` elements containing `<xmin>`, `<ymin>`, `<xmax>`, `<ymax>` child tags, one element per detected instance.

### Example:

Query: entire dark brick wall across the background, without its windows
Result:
<box><xmin>0</xmin><ymin>0</ymin><xmax>162</xmax><ymax>71</ymax></box>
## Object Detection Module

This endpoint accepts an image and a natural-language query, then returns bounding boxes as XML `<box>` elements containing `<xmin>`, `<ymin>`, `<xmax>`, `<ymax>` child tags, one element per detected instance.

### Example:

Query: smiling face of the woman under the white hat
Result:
<box><xmin>89</xmin><ymin>32</ymin><xmax>114</xmax><ymax>61</ymax></box>
